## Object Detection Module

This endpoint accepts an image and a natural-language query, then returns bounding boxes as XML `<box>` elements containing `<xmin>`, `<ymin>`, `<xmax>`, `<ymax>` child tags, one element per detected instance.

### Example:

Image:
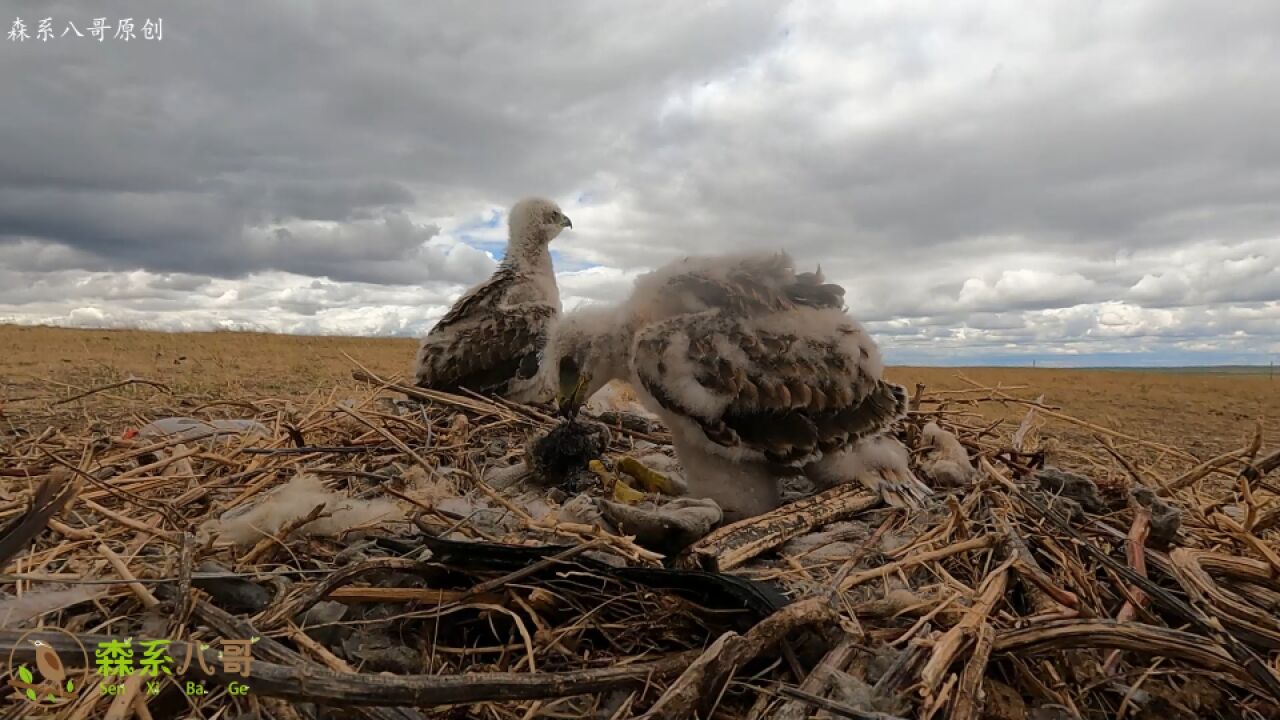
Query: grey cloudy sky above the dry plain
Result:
<box><xmin>0</xmin><ymin>0</ymin><xmax>1280</xmax><ymax>364</ymax></box>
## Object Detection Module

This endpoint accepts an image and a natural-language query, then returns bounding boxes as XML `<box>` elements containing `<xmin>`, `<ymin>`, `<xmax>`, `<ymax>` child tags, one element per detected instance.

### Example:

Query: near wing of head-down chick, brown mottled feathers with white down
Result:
<box><xmin>631</xmin><ymin>309</ymin><xmax>906</xmax><ymax>465</ymax></box>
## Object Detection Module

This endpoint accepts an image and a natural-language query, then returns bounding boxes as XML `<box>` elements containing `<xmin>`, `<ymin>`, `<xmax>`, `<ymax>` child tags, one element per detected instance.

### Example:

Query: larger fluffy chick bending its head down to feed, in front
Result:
<box><xmin>554</xmin><ymin>252</ymin><xmax>906</xmax><ymax>521</ymax></box>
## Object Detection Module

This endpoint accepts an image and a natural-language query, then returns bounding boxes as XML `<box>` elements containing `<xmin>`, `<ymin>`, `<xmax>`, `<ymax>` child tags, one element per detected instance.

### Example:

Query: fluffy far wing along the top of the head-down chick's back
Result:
<box><xmin>635</xmin><ymin>252</ymin><xmax>845</xmax><ymax>316</ymax></box>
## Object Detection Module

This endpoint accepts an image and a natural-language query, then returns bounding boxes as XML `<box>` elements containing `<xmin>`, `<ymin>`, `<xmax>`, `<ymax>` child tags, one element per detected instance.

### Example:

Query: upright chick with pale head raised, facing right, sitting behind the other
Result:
<box><xmin>413</xmin><ymin>199</ymin><xmax>573</xmax><ymax>402</ymax></box>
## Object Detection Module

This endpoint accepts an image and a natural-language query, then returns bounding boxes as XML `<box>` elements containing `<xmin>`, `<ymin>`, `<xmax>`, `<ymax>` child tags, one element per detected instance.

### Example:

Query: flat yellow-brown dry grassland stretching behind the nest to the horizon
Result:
<box><xmin>0</xmin><ymin>325</ymin><xmax>1280</xmax><ymax>457</ymax></box>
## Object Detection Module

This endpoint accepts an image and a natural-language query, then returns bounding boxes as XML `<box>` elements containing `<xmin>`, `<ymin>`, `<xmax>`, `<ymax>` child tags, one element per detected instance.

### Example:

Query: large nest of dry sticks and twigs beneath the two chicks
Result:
<box><xmin>0</xmin><ymin>370</ymin><xmax>1280</xmax><ymax>719</ymax></box>
